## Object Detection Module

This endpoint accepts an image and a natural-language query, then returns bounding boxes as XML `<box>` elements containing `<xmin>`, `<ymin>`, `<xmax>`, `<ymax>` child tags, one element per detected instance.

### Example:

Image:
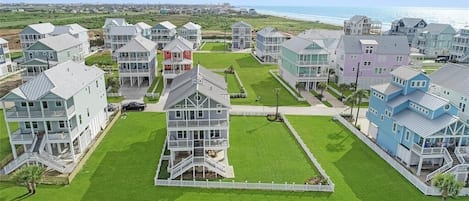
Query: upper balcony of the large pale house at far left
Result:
<box><xmin>6</xmin><ymin>105</ymin><xmax>75</xmax><ymax>119</ymax></box>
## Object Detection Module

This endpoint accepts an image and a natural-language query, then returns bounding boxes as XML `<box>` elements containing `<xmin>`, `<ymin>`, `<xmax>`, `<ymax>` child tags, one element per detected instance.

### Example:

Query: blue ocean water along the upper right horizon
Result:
<box><xmin>247</xmin><ymin>6</ymin><xmax>469</xmax><ymax>30</ymax></box>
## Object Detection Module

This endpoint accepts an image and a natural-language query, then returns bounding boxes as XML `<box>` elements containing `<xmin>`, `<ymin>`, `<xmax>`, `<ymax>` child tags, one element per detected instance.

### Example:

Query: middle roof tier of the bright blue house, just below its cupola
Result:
<box><xmin>388</xmin><ymin>90</ymin><xmax>449</xmax><ymax>110</ymax></box>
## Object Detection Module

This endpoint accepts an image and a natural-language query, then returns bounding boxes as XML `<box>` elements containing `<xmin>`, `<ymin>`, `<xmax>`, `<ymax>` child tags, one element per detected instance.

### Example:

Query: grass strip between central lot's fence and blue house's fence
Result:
<box><xmin>287</xmin><ymin>116</ymin><xmax>442</xmax><ymax>201</ymax></box>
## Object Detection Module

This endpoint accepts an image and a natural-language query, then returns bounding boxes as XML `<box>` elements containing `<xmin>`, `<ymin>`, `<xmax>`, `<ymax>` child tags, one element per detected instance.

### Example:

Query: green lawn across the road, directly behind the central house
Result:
<box><xmin>194</xmin><ymin>53</ymin><xmax>309</xmax><ymax>106</ymax></box>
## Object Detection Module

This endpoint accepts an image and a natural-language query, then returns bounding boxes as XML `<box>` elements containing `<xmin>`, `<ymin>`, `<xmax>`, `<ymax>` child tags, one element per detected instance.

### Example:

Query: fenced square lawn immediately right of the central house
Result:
<box><xmin>226</xmin><ymin>116</ymin><xmax>318</xmax><ymax>184</ymax></box>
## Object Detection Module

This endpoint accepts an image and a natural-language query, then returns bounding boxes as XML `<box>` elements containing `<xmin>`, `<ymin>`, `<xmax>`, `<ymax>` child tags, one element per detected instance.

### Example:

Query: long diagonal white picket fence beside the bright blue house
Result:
<box><xmin>334</xmin><ymin>115</ymin><xmax>469</xmax><ymax>196</ymax></box>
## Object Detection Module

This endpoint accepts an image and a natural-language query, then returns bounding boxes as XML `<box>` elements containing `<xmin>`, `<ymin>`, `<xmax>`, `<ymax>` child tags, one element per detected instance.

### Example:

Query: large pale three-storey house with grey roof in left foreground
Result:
<box><xmin>0</xmin><ymin>61</ymin><xmax>107</xmax><ymax>174</ymax></box>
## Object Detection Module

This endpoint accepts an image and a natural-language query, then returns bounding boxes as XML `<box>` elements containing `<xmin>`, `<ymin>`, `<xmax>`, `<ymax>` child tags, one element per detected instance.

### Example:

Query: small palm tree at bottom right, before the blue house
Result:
<box><xmin>432</xmin><ymin>173</ymin><xmax>463</xmax><ymax>201</ymax></box>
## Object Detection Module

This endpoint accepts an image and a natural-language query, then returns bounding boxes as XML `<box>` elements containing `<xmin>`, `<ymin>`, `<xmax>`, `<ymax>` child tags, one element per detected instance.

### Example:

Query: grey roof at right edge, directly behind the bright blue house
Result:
<box><xmin>429</xmin><ymin>63</ymin><xmax>469</xmax><ymax>96</ymax></box>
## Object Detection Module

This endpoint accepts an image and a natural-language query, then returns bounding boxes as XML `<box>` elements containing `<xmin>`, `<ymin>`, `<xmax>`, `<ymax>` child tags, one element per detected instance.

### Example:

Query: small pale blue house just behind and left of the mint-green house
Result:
<box><xmin>255</xmin><ymin>27</ymin><xmax>287</xmax><ymax>63</ymax></box>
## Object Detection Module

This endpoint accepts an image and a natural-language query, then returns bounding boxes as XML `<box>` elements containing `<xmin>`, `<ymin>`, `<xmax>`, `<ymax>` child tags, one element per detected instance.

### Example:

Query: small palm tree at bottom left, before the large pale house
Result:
<box><xmin>13</xmin><ymin>165</ymin><xmax>45</xmax><ymax>194</ymax></box>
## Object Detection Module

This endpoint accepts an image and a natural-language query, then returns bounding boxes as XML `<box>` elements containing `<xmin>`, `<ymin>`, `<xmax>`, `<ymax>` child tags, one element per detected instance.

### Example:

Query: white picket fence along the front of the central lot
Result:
<box><xmin>155</xmin><ymin>179</ymin><xmax>334</xmax><ymax>192</ymax></box>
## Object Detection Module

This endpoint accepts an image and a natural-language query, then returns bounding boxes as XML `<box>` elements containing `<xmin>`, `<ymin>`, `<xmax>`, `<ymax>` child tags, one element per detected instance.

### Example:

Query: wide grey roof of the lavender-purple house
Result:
<box><xmin>341</xmin><ymin>35</ymin><xmax>410</xmax><ymax>55</ymax></box>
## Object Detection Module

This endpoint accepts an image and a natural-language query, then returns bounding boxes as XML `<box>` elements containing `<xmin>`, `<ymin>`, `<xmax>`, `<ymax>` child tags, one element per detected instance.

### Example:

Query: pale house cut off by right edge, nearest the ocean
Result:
<box><xmin>449</xmin><ymin>26</ymin><xmax>469</xmax><ymax>63</ymax></box>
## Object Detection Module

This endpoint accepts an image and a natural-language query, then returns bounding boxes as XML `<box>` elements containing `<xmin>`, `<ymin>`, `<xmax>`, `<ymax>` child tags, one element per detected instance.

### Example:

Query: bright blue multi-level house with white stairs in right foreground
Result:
<box><xmin>366</xmin><ymin>66</ymin><xmax>469</xmax><ymax>182</ymax></box>
